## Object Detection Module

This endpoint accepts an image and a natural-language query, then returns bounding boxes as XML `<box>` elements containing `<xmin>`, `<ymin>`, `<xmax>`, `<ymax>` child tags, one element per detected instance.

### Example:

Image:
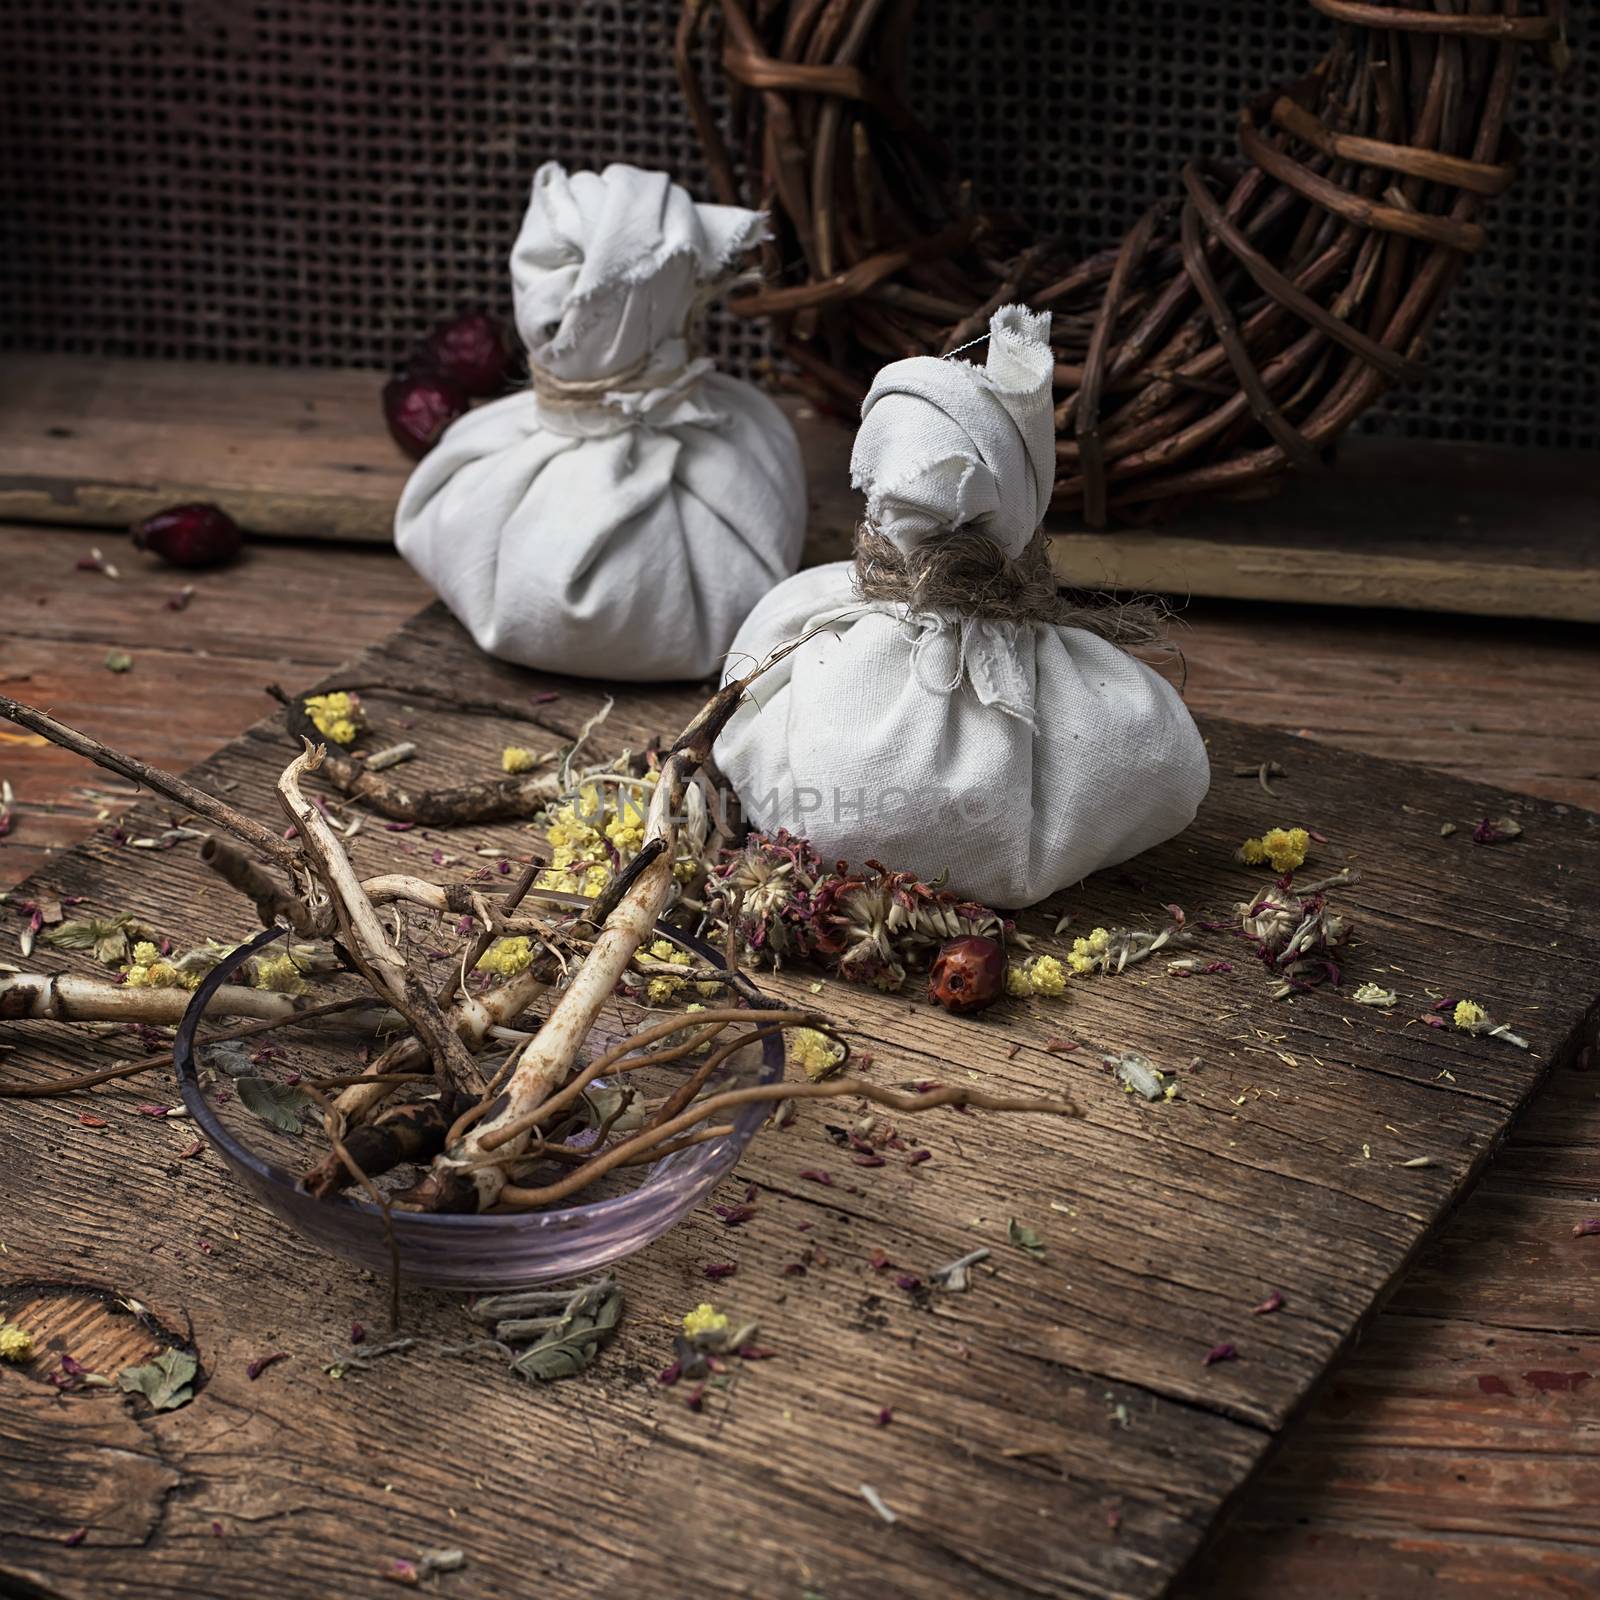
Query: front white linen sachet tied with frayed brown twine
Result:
<box><xmin>715</xmin><ymin>306</ymin><xmax>1210</xmax><ymax>907</ymax></box>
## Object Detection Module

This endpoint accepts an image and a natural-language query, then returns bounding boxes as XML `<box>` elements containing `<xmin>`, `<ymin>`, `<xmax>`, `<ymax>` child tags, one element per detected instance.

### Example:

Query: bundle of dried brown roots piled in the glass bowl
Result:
<box><xmin>0</xmin><ymin>664</ymin><xmax>1075</xmax><ymax>1211</ymax></box>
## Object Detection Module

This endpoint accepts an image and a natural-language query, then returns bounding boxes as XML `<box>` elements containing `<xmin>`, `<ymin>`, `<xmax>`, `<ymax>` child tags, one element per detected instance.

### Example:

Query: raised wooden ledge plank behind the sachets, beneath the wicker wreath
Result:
<box><xmin>0</xmin><ymin>355</ymin><xmax>1600</xmax><ymax>622</ymax></box>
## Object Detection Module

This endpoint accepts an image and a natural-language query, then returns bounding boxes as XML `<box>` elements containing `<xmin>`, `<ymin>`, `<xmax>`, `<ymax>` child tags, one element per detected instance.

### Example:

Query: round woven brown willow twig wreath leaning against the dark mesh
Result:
<box><xmin>677</xmin><ymin>0</ymin><xmax>1565</xmax><ymax>526</ymax></box>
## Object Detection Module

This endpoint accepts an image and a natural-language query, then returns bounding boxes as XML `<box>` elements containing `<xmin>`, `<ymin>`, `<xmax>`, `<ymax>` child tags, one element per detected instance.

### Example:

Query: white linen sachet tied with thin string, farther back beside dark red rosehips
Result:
<box><xmin>395</xmin><ymin>162</ymin><xmax>805</xmax><ymax>682</ymax></box>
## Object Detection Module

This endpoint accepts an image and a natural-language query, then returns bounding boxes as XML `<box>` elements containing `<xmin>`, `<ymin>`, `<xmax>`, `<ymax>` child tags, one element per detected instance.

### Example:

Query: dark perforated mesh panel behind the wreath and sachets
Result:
<box><xmin>0</xmin><ymin>0</ymin><xmax>1600</xmax><ymax>448</ymax></box>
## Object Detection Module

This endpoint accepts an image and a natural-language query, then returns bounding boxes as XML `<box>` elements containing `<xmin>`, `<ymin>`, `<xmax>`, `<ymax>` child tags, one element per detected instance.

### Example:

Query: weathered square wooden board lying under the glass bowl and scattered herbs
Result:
<box><xmin>0</xmin><ymin>611</ymin><xmax>1600</xmax><ymax>1600</ymax></box>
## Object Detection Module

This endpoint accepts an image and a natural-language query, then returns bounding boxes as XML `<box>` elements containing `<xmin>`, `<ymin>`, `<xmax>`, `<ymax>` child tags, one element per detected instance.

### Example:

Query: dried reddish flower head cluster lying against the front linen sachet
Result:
<box><xmin>707</xmin><ymin>829</ymin><xmax>1010</xmax><ymax>990</ymax></box>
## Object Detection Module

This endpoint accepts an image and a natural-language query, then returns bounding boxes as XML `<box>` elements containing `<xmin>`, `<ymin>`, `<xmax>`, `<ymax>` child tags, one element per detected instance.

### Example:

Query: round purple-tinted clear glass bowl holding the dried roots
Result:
<box><xmin>173</xmin><ymin>925</ymin><xmax>784</xmax><ymax>1290</ymax></box>
